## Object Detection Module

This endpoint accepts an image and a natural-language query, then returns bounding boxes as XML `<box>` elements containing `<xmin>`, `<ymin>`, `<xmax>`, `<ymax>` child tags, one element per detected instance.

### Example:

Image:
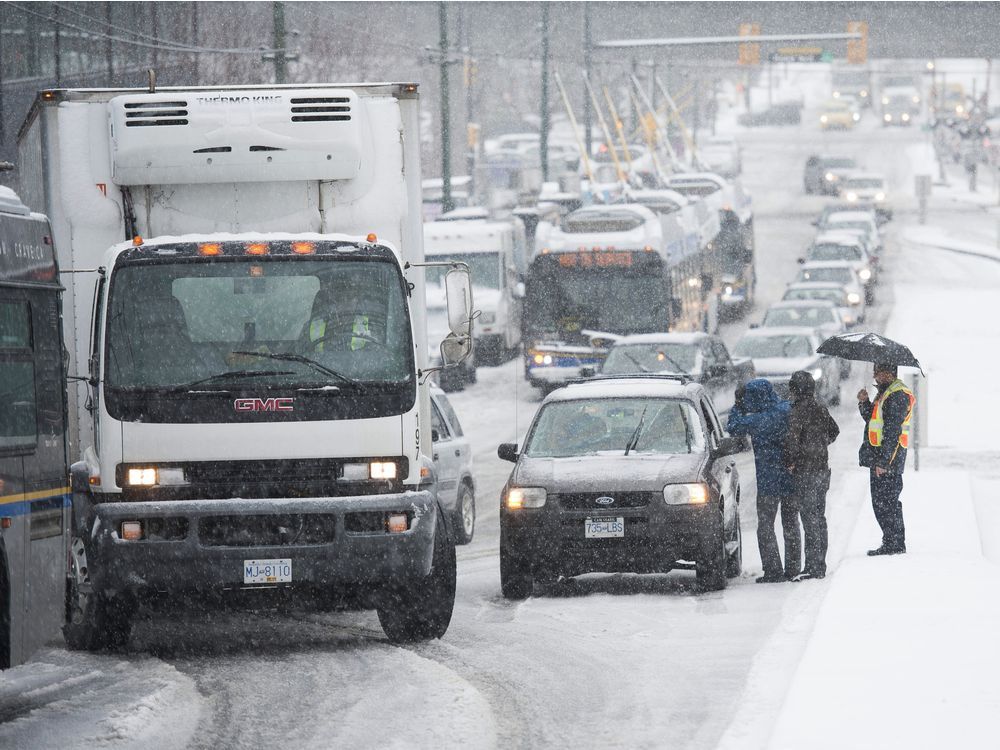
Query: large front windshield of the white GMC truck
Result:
<box><xmin>105</xmin><ymin>257</ymin><xmax>414</xmax><ymax>390</ymax></box>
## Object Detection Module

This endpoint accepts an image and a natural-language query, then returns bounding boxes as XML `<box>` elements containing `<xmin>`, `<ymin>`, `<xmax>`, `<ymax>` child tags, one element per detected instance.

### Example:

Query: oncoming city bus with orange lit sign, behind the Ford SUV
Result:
<box><xmin>524</xmin><ymin>206</ymin><xmax>711</xmax><ymax>391</ymax></box>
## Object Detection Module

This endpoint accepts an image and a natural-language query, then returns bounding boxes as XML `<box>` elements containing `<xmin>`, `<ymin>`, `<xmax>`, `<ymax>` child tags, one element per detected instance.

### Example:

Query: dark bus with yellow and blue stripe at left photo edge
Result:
<box><xmin>0</xmin><ymin>186</ymin><xmax>71</xmax><ymax>668</ymax></box>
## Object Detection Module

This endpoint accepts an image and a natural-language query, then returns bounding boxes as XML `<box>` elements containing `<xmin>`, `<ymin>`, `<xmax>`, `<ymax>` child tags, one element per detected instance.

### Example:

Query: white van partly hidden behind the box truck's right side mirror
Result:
<box><xmin>424</xmin><ymin>219</ymin><xmax>526</xmax><ymax>365</ymax></box>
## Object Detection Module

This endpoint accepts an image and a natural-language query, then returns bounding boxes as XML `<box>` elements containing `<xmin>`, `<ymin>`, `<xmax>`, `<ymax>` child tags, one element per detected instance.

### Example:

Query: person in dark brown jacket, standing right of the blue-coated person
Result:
<box><xmin>785</xmin><ymin>370</ymin><xmax>840</xmax><ymax>581</ymax></box>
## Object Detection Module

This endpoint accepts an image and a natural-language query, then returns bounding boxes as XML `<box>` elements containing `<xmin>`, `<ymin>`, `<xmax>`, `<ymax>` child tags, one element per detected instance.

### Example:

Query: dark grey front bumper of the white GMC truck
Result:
<box><xmin>87</xmin><ymin>490</ymin><xmax>434</xmax><ymax>593</ymax></box>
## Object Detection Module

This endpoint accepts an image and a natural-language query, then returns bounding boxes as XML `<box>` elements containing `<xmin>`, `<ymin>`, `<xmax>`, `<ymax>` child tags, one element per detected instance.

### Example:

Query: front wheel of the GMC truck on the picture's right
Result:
<box><xmin>376</xmin><ymin>516</ymin><xmax>457</xmax><ymax>643</ymax></box>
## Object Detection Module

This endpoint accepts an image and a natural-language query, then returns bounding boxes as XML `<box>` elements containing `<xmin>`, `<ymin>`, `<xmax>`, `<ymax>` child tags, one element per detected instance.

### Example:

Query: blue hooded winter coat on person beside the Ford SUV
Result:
<box><xmin>726</xmin><ymin>378</ymin><xmax>793</xmax><ymax>497</ymax></box>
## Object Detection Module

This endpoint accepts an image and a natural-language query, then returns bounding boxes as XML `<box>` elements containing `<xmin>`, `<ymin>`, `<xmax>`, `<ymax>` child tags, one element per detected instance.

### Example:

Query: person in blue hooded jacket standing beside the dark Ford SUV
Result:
<box><xmin>726</xmin><ymin>378</ymin><xmax>802</xmax><ymax>583</ymax></box>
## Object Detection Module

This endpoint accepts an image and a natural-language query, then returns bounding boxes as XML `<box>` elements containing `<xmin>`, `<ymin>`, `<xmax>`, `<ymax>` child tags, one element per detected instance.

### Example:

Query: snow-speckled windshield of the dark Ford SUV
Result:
<box><xmin>524</xmin><ymin>398</ymin><xmax>705</xmax><ymax>458</ymax></box>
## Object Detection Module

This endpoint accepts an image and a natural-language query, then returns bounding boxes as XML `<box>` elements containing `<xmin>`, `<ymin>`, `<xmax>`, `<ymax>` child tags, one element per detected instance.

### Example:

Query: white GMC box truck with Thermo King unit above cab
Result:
<box><xmin>18</xmin><ymin>84</ymin><xmax>472</xmax><ymax>649</ymax></box>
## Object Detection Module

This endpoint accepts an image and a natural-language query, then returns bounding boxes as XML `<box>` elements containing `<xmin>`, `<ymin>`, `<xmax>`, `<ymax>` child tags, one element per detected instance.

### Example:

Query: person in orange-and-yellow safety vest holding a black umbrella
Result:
<box><xmin>858</xmin><ymin>364</ymin><xmax>915</xmax><ymax>555</ymax></box>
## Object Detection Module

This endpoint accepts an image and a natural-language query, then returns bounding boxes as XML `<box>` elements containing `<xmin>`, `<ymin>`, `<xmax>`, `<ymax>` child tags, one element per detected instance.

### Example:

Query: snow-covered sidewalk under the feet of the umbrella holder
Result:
<box><xmin>767</xmin><ymin>471</ymin><xmax>1000</xmax><ymax>750</ymax></box>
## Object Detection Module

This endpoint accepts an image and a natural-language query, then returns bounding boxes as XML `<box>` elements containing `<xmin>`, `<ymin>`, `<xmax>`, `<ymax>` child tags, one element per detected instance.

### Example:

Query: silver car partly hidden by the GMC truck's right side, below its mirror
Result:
<box><xmin>430</xmin><ymin>387</ymin><xmax>476</xmax><ymax>544</ymax></box>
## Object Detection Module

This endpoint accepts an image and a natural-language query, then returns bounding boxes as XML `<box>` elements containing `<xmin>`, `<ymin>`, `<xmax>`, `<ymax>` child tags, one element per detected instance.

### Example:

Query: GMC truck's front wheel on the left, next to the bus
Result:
<box><xmin>63</xmin><ymin>537</ymin><xmax>132</xmax><ymax>651</ymax></box>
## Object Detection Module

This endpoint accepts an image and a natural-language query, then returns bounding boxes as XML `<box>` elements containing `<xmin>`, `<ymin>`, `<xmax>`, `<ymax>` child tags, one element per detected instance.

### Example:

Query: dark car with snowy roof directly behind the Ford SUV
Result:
<box><xmin>601</xmin><ymin>333</ymin><xmax>754</xmax><ymax>414</ymax></box>
